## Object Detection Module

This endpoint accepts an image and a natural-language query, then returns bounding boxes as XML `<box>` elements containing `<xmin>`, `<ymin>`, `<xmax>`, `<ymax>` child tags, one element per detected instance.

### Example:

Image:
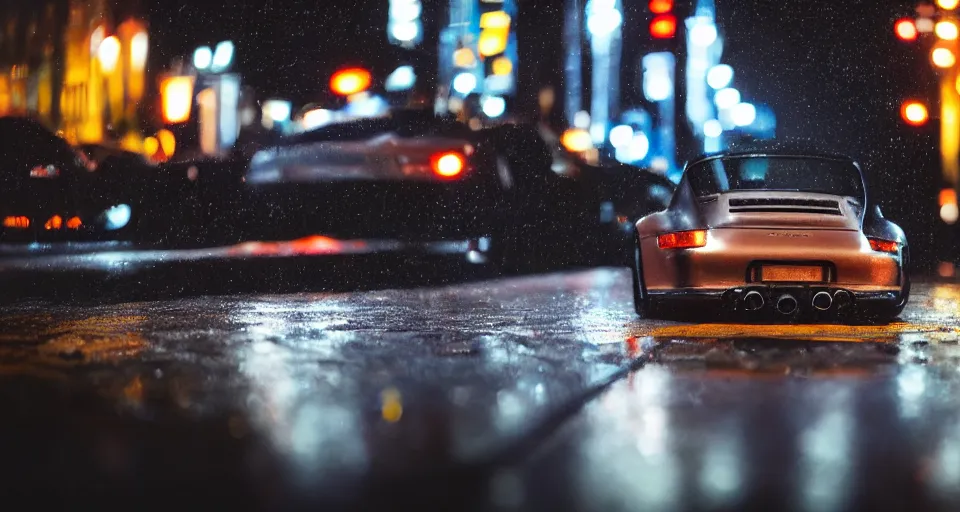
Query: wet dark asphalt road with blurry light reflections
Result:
<box><xmin>0</xmin><ymin>269</ymin><xmax>960</xmax><ymax>511</ymax></box>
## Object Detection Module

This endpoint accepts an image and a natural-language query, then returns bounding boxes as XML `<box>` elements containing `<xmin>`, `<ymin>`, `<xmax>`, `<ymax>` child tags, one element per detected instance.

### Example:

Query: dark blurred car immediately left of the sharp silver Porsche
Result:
<box><xmin>480</xmin><ymin>124</ymin><xmax>675</xmax><ymax>269</ymax></box>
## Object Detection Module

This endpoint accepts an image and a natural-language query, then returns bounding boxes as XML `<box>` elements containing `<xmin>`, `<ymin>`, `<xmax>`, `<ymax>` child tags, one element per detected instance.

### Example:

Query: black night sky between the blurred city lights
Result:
<box><xmin>144</xmin><ymin>0</ymin><xmax>938</xmax><ymax>230</ymax></box>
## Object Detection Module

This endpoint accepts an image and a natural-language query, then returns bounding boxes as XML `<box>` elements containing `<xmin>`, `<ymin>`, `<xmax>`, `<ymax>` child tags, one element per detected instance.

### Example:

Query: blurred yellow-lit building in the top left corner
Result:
<box><xmin>0</xmin><ymin>0</ymin><xmax>149</xmax><ymax>151</ymax></box>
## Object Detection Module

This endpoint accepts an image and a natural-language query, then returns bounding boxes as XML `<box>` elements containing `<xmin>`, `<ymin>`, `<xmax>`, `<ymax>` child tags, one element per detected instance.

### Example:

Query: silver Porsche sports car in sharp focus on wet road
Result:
<box><xmin>633</xmin><ymin>151</ymin><xmax>910</xmax><ymax>320</ymax></box>
